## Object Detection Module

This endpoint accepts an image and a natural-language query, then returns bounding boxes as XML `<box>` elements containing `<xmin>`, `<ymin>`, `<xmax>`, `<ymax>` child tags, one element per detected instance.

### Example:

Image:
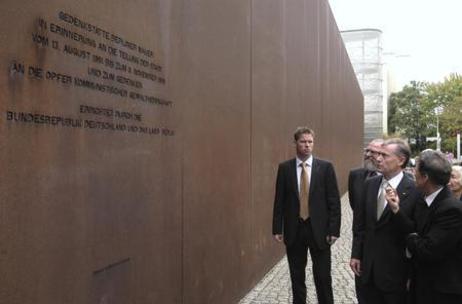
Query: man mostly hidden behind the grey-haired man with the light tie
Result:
<box><xmin>348</xmin><ymin>138</ymin><xmax>383</xmax><ymax>304</ymax></box>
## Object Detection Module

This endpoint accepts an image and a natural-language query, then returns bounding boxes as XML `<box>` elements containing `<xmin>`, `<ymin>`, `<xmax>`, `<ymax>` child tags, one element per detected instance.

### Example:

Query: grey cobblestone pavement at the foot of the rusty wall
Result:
<box><xmin>239</xmin><ymin>194</ymin><xmax>357</xmax><ymax>304</ymax></box>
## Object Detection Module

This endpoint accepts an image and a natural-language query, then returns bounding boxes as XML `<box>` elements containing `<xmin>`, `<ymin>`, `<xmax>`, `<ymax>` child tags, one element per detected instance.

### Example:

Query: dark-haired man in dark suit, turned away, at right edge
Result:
<box><xmin>407</xmin><ymin>150</ymin><xmax>462</xmax><ymax>304</ymax></box>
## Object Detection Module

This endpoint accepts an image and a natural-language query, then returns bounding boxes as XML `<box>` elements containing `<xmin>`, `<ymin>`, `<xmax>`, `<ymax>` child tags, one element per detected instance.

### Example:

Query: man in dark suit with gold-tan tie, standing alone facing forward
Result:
<box><xmin>273</xmin><ymin>127</ymin><xmax>340</xmax><ymax>304</ymax></box>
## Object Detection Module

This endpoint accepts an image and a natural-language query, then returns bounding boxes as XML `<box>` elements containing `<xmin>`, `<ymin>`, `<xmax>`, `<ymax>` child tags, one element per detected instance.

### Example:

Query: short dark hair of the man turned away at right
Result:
<box><xmin>417</xmin><ymin>149</ymin><xmax>452</xmax><ymax>186</ymax></box>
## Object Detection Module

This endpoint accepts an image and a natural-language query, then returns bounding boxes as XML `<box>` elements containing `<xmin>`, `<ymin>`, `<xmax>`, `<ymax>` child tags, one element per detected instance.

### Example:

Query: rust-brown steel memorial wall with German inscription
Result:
<box><xmin>0</xmin><ymin>0</ymin><xmax>363</xmax><ymax>304</ymax></box>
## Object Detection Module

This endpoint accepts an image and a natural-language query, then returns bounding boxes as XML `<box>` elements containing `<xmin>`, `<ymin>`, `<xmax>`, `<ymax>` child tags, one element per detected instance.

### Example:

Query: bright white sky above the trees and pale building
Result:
<box><xmin>329</xmin><ymin>0</ymin><xmax>462</xmax><ymax>89</ymax></box>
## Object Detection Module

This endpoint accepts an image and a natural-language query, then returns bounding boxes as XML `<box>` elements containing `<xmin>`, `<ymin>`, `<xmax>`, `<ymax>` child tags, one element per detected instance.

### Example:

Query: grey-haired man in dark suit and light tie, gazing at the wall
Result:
<box><xmin>350</xmin><ymin>139</ymin><xmax>416</xmax><ymax>304</ymax></box>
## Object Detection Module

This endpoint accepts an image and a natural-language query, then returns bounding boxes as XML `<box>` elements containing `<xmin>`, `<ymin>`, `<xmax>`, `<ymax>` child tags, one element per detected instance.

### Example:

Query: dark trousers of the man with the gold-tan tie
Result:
<box><xmin>286</xmin><ymin>219</ymin><xmax>334</xmax><ymax>304</ymax></box>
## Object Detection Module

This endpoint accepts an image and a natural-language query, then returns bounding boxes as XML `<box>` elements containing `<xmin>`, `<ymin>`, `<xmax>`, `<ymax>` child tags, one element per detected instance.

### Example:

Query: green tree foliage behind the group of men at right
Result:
<box><xmin>388</xmin><ymin>74</ymin><xmax>462</xmax><ymax>153</ymax></box>
